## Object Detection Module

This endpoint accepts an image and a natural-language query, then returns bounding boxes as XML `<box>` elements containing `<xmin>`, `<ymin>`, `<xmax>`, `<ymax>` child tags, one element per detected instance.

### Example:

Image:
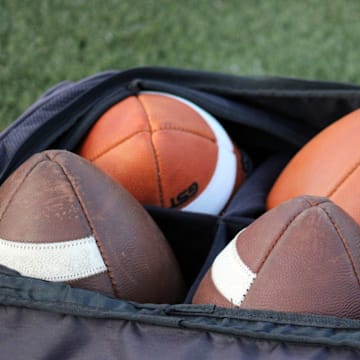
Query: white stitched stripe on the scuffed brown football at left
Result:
<box><xmin>0</xmin><ymin>236</ymin><xmax>107</xmax><ymax>281</ymax></box>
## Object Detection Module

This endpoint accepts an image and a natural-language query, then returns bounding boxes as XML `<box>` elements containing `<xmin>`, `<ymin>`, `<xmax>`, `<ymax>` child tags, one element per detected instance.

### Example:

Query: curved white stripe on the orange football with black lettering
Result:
<box><xmin>143</xmin><ymin>91</ymin><xmax>237</xmax><ymax>215</ymax></box>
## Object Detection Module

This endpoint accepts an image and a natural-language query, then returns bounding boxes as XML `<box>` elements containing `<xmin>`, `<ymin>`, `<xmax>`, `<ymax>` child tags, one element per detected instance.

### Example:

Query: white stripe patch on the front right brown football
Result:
<box><xmin>211</xmin><ymin>234</ymin><xmax>256</xmax><ymax>306</ymax></box>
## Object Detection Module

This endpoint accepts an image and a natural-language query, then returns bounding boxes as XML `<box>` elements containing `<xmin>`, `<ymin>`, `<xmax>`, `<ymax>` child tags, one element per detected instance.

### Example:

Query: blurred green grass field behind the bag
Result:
<box><xmin>0</xmin><ymin>0</ymin><xmax>360</xmax><ymax>129</ymax></box>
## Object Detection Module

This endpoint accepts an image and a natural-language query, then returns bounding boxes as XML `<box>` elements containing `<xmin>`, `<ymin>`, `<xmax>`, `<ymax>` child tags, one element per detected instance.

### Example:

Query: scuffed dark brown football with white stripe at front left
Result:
<box><xmin>0</xmin><ymin>150</ymin><xmax>184</xmax><ymax>303</ymax></box>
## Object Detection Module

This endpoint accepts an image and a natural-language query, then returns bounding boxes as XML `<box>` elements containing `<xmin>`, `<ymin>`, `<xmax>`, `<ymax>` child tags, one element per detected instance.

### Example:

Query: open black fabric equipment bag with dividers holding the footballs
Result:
<box><xmin>0</xmin><ymin>67</ymin><xmax>360</xmax><ymax>360</ymax></box>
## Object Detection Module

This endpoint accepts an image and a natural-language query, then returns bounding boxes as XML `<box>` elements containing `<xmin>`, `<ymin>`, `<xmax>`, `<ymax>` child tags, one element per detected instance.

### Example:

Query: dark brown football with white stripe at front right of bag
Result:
<box><xmin>193</xmin><ymin>196</ymin><xmax>360</xmax><ymax>319</ymax></box>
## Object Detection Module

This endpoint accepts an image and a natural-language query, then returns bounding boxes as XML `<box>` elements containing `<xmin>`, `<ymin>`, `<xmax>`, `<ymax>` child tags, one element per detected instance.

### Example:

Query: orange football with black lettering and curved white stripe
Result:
<box><xmin>77</xmin><ymin>92</ymin><xmax>249</xmax><ymax>214</ymax></box>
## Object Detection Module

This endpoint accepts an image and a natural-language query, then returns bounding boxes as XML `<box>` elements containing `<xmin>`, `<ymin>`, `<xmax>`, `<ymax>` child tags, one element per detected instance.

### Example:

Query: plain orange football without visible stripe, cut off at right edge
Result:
<box><xmin>267</xmin><ymin>110</ymin><xmax>360</xmax><ymax>223</ymax></box>
